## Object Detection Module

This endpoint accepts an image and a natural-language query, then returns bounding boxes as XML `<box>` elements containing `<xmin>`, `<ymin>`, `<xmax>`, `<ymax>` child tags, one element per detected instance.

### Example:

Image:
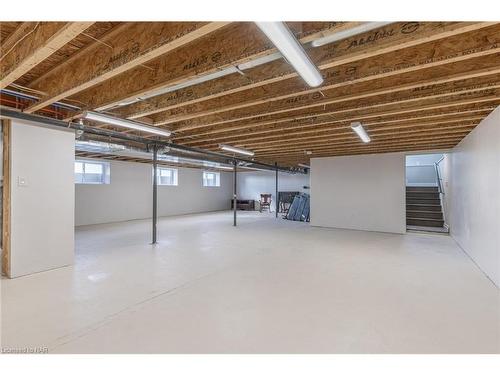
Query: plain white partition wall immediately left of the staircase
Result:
<box><xmin>311</xmin><ymin>153</ymin><xmax>406</xmax><ymax>233</ymax></box>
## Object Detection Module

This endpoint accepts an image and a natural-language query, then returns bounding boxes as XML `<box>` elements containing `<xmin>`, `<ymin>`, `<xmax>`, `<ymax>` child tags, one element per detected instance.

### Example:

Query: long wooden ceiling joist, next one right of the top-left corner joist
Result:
<box><xmin>25</xmin><ymin>22</ymin><xmax>228</xmax><ymax>113</ymax></box>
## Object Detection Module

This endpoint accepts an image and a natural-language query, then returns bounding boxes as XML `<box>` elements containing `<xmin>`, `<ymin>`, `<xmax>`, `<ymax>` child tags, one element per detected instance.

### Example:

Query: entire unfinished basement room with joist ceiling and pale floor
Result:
<box><xmin>0</xmin><ymin>3</ymin><xmax>500</xmax><ymax>368</ymax></box>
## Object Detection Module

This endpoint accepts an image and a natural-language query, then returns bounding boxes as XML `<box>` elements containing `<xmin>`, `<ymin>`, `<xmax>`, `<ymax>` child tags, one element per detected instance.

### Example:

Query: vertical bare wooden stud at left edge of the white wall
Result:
<box><xmin>1</xmin><ymin>120</ymin><xmax>12</xmax><ymax>277</ymax></box>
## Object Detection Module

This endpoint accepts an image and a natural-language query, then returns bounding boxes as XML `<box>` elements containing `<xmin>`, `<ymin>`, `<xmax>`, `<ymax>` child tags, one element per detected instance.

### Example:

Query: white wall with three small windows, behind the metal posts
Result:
<box><xmin>75</xmin><ymin>161</ymin><xmax>233</xmax><ymax>225</ymax></box>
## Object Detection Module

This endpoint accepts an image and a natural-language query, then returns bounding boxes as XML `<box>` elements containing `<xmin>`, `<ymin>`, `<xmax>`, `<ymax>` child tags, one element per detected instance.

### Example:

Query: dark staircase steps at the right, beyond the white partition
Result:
<box><xmin>406</xmin><ymin>186</ymin><xmax>444</xmax><ymax>229</ymax></box>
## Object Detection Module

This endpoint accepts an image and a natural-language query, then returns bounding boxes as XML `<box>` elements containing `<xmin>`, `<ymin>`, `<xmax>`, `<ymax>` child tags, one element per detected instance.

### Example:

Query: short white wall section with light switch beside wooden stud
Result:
<box><xmin>10</xmin><ymin>120</ymin><xmax>75</xmax><ymax>277</ymax></box>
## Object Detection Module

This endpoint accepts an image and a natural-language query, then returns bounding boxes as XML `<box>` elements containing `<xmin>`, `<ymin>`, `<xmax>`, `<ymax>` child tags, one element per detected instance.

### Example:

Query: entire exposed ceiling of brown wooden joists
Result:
<box><xmin>0</xmin><ymin>22</ymin><xmax>500</xmax><ymax>165</ymax></box>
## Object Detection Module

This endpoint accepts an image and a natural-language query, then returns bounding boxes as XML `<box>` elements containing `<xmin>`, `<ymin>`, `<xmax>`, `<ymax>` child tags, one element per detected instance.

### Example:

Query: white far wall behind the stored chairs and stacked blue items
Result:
<box><xmin>237</xmin><ymin>171</ymin><xmax>309</xmax><ymax>210</ymax></box>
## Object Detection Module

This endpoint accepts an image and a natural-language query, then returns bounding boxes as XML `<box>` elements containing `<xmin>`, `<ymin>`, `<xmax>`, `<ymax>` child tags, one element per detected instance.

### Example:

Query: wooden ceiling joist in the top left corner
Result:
<box><xmin>0</xmin><ymin>22</ymin><xmax>93</xmax><ymax>89</ymax></box>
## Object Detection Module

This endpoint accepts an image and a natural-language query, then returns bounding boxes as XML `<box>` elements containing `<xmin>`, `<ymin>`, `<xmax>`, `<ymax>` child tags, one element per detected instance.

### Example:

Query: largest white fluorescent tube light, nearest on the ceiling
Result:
<box><xmin>256</xmin><ymin>22</ymin><xmax>323</xmax><ymax>87</ymax></box>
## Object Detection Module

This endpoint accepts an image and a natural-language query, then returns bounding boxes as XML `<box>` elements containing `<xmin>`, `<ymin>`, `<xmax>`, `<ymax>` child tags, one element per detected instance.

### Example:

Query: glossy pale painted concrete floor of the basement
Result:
<box><xmin>1</xmin><ymin>212</ymin><xmax>500</xmax><ymax>353</ymax></box>
